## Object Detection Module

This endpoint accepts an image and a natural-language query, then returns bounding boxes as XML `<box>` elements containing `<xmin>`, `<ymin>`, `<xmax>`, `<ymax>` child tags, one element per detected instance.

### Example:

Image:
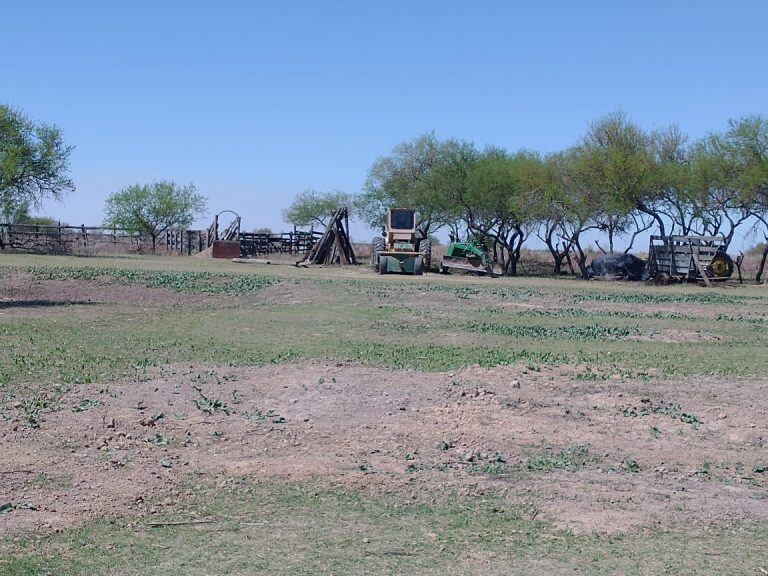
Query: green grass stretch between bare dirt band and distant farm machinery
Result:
<box><xmin>0</xmin><ymin>257</ymin><xmax>768</xmax><ymax>395</ymax></box>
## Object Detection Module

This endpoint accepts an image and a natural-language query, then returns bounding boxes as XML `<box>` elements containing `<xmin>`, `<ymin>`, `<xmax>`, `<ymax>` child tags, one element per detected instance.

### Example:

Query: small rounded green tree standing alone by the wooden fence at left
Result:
<box><xmin>104</xmin><ymin>180</ymin><xmax>207</xmax><ymax>253</ymax></box>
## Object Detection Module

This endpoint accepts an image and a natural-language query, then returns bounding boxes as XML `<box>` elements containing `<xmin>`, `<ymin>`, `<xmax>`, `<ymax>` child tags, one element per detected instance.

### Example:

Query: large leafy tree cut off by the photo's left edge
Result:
<box><xmin>0</xmin><ymin>104</ymin><xmax>75</xmax><ymax>220</ymax></box>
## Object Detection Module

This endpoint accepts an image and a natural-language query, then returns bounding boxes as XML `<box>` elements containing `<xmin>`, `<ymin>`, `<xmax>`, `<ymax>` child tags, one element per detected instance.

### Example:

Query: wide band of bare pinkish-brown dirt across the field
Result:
<box><xmin>0</xmin><ymin>361</ymin><xmax>768</xmax><ymax>536</ymax></box>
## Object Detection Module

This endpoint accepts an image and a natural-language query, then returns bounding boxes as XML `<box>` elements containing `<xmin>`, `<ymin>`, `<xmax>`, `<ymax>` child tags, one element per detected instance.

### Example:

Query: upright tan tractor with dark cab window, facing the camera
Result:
<box><xmin>371</xmin><ymin>209</ymin><xmax>432</xmax><ymax>276</ymax></box>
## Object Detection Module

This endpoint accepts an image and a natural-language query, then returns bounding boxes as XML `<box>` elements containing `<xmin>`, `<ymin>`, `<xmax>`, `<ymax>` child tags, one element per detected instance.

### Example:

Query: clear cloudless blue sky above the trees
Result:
<box><xmin>0</xmin><ymin>0</ymin><xmax>768</xmax><ymax>240</ymax></box>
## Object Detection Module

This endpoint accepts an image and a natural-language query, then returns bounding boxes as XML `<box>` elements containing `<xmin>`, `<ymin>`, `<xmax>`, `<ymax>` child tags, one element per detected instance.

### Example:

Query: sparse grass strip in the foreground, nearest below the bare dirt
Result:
<box><xmin>0</xmin><ymin>480</ymin><xmax>768</xmax><ymax>576</ymax></box>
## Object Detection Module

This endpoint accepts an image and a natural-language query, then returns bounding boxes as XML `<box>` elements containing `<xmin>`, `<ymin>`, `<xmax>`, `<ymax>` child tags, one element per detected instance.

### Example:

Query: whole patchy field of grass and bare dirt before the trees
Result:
<box><xmin>0</xmin><ymin>255</ymin><xmax>768</xmax><ymax>575</ymax></box>
